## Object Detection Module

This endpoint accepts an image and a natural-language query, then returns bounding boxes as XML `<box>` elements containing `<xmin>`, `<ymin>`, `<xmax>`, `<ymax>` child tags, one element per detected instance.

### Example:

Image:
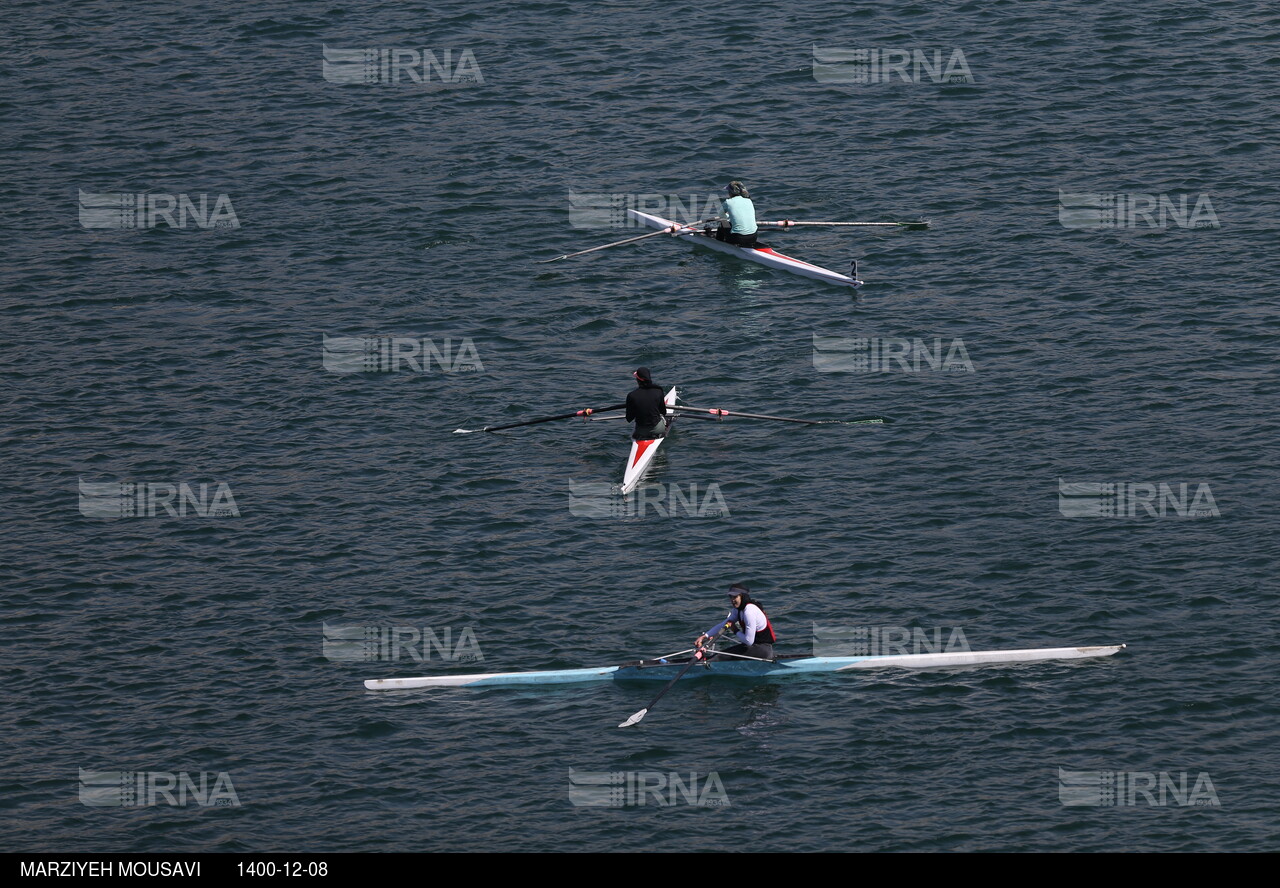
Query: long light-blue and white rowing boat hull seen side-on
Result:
<box><xmin>365</xmin><ymin>645</ymin><xmax>1125</xmax><ymax>691</ymax></box>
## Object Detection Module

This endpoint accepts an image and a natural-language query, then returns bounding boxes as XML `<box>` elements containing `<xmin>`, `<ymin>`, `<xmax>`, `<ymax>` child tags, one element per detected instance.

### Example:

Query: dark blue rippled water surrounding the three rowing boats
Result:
<box><xmin>0</xmin><ymin>3</ymin><xmax>1280</xmax><ymax>852</ymax></box>
